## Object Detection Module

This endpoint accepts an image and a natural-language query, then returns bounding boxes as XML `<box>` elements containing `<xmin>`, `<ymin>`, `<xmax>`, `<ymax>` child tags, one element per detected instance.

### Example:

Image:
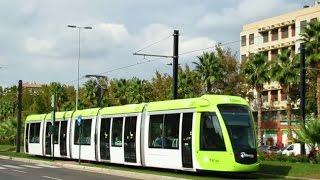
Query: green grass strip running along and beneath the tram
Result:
<box><xmin>0</xmin><ymin>145</ymin><xmax>320</xmax><ymax>179</ymax></box>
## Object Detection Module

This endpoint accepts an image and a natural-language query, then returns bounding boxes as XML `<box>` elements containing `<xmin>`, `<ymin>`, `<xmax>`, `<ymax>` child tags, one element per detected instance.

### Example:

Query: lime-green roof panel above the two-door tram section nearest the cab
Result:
<box><xmin>99</xmin><ymin>103</ymin><xmax>145</xmax><ymax>116</ymax></box>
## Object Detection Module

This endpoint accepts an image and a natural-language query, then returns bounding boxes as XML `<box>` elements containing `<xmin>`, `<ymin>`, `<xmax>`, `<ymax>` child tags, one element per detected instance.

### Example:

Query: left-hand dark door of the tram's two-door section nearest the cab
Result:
<box><xmin>100</xmin><ymin>118</ymin><xmax>111</xmax><ymax>160</ymax></box>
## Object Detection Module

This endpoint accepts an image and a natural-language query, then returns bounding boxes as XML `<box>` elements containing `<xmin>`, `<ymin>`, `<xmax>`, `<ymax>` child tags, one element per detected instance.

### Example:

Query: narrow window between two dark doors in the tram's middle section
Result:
<box><xmin>111</xmin><ymin>117</ymin><xmax>123</xmax><ymax>147</ymax></box>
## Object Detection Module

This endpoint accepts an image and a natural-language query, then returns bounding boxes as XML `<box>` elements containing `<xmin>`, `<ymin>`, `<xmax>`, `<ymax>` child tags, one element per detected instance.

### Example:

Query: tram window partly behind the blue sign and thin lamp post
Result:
<box><xmin>74</xmin><ymin>119</ymin><xmax>92</xmax><ymax>145</ymax></box>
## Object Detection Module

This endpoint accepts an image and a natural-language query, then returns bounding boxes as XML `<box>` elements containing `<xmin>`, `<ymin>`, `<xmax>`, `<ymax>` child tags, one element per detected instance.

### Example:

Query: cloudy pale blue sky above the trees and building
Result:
<box><xmin>0</xmin><ymin>0</ymin><xmax>313</xmax><ymax>87</ymax></box>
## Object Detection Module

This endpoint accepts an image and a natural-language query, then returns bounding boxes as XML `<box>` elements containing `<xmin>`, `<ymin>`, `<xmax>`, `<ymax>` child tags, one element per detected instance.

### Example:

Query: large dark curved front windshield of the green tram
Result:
<box><xmin>218</xmin><ymin>104</ymin><xmax>256</xmax><ymax>151</ymax></box>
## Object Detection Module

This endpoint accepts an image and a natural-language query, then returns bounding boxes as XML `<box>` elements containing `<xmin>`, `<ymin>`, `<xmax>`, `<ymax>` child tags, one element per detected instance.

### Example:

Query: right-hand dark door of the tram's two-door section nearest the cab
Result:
<box><xmin>124</xmin><ymin>116</ymin><xmax>137</xmax><ymax>163</ymax></box>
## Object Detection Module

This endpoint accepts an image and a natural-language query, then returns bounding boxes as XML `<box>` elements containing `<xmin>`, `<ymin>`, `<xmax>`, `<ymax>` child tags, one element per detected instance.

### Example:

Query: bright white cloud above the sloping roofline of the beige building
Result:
<box><xmin>196</xmin><ymin>0</ymin><xmax>299</xmax><ymax>41</ymax></box>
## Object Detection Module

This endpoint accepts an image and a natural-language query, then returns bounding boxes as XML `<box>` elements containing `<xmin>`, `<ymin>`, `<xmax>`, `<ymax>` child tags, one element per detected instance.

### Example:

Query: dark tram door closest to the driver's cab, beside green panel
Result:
<box><xmin>181</xmin><ymin>113</ymin><xmax>193</xmax><ymax>168</ymax></box>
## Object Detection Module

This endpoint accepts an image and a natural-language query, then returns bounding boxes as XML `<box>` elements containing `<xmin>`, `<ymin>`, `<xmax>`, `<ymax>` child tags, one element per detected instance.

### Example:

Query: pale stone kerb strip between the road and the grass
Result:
<box><xmin>0</xmin><ymin>155</ymin><xmax>182</xmax><ymax>180</ymax></box>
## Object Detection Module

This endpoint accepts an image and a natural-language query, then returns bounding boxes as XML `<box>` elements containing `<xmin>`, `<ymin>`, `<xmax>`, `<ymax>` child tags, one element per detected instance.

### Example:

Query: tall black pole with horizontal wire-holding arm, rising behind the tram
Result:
<box><xmin>133</xmin><ymin>30</ymin><xmax>179</xmax><ymax>99</ymax></box>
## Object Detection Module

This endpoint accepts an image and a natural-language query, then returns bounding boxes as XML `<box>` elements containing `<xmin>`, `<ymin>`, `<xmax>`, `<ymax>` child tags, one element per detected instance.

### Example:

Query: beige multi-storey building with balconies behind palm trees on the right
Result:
<box><xmin>240</xmin><ymin>2</ymin><xmax>320</xmax><ymax>145</ymax></box>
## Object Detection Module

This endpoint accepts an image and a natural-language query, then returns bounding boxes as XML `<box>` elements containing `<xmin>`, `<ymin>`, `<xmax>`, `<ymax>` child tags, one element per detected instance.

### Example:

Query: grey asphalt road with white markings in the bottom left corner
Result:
<box><xmin>0</xmin><ymin>159</ymin><xmax>135</xmax><ymax>180</ymax></box>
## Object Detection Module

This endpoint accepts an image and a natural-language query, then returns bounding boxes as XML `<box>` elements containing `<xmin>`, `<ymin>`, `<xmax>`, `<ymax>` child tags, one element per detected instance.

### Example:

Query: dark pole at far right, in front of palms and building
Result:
<box><xmin>300</xmin><ymin>44</ymin><xmax>306</xmax><ymax>155</ymax></box>
